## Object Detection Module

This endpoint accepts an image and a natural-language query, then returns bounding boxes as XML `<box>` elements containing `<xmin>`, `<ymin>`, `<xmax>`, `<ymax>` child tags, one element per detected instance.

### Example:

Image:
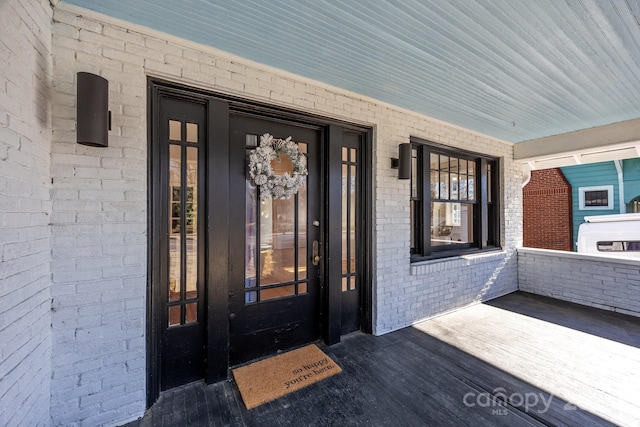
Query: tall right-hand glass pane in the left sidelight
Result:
<box><xmin>184</xmin><ymin>147</ymin><xmax>198</xmax><ymax>298</ymax></box>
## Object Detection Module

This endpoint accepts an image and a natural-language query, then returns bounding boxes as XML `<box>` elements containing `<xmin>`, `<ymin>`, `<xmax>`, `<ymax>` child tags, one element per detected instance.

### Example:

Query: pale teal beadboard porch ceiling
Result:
<box><xmin>64</xmin><ymin>0</ymin><xmax>640</xmax><ymax>142</ymax></box>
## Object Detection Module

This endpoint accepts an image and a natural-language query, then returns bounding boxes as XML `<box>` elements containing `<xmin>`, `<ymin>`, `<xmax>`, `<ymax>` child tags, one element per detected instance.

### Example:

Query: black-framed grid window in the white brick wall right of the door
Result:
<box><xmin>410</xmin><ymin>140</ymin><xmax>499</xmax><ymax>261</ymax></box>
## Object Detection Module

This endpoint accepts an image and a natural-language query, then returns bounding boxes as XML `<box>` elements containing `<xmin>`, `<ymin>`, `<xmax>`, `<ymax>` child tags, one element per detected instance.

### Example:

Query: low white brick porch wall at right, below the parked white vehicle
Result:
<box><xmin>518</xmin><ymin>248</ymin><xmax>640</xmax><ymax>316</ymax></box>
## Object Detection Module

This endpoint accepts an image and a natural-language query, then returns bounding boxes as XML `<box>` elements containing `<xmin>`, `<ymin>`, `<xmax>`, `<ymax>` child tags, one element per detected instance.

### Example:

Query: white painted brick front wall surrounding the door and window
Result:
<box><xmin>51</xmin><ymin>3</ymin><xmax>522</xmax><ymax>425</ymax></box>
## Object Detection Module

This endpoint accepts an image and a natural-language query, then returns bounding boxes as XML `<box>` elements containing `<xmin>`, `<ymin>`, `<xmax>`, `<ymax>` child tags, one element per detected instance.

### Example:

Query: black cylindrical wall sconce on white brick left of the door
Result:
<box><xmin>76</xmin><ymin>72</ymin><xmax>111</xmax><ymax>147</ymax></box>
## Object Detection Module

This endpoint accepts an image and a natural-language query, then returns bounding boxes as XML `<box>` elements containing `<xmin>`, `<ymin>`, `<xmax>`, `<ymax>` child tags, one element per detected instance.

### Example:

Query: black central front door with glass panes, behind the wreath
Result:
<box><xmin>229</xmin><ymin>114</ymin><xmax>322</xmax><ymax>365</ymax></box>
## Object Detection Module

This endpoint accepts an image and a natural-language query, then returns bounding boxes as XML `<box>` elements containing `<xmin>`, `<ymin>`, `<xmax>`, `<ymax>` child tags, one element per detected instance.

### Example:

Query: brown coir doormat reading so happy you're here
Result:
<box><xmin>232</xmin><ymin>344</ymin><xmax>342</xmax><ymax>409</ymax></box>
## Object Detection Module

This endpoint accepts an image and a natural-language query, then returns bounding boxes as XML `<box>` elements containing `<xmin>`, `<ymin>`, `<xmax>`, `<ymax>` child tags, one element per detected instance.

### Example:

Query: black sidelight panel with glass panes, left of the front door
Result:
<box><xmin>152</xmin><ymin>97</ymin><xmax>207</xmax><ymax>390</ymax></box>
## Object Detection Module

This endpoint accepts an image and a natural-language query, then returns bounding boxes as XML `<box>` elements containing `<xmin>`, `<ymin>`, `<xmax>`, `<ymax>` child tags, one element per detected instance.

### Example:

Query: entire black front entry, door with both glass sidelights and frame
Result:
<box><xmin>147</xmin><ymin>81</ymin><xmax>372</xmax><ymax>404</ymax></box>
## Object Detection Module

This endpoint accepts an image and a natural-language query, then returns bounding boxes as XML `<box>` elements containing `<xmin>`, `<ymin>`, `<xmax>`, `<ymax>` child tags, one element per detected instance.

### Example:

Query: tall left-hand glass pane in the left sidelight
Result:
<box><xmin>169</xmin><ymin>145</ymin><xmax>183</xmax><ymax>301</ymax></box>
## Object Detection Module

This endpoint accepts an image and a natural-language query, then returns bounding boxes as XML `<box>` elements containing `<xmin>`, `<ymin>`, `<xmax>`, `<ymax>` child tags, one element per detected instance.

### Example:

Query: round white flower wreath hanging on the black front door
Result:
<box><xmin>249</xmin><ymin>133</ymin><xmax>309</xmax><ymax>199</ymax></box>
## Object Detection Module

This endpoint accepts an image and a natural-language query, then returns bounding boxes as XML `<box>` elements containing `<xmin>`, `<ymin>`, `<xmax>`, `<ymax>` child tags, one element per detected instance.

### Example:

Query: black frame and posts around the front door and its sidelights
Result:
<box><xmin>146</xmin><ymin>77</ymin><xmax>374</xmax><ymax>407</ymax></box>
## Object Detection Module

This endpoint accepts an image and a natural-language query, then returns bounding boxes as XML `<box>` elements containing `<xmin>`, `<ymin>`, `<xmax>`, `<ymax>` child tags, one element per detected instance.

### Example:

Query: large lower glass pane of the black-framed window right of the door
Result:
<box><xmin>431</xmin><ymin>202</ymin><xmax>473</xmax><ymax>247</ymax></box>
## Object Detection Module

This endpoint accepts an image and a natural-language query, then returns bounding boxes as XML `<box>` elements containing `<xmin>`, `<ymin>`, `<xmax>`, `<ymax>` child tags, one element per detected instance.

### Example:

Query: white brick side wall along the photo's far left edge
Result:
<box><xmin>0</xmin><ymin>0</ymin><xmax>52</xmax><ymax>426</ymax></box>
